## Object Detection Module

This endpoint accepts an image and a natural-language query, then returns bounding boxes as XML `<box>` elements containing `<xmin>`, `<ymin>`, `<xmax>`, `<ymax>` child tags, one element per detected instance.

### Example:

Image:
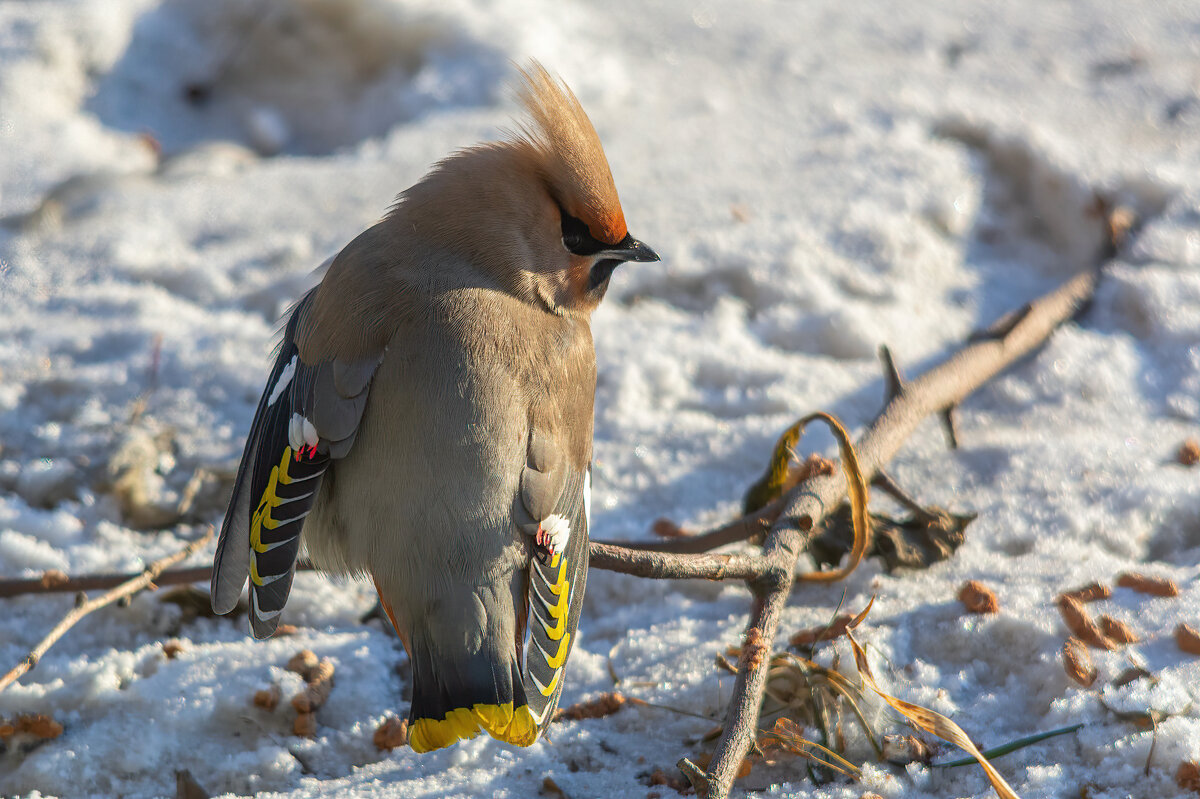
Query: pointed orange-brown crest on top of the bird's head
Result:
<box><xmin>517</xmin><ymin>61</ymin><xmax>628</xmax><ymax>244</ymax></box>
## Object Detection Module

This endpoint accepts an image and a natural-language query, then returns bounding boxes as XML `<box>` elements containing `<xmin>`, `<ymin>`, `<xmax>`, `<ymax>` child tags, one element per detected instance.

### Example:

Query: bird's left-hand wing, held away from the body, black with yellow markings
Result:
<box><xmin>211</xmin><ymin>289</ymin><xmax>383</xmax><ymax>638</ymax></box>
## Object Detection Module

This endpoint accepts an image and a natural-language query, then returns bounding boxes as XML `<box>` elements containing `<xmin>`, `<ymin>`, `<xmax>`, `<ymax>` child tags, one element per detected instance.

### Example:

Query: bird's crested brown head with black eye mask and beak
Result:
<box><xmin>395</xmin><ymin>62</ymin><xmax>659</xmax><ymax>314</ymax></box>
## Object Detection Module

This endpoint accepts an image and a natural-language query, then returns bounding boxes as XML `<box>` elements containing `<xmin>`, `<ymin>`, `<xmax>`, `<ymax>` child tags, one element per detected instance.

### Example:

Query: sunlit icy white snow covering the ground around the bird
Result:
<box><xmin>0</xmin><ymin>0</ymin><xmax>1200</xmax><ymax>799</ymax></box>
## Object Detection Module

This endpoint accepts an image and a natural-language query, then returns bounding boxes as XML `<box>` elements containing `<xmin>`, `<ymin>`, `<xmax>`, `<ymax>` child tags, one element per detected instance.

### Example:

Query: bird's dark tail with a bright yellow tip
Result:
<box><xmin>408</xmin><ymin>633</ymin><xmax>539</xmax><ymax>752</ymax></box>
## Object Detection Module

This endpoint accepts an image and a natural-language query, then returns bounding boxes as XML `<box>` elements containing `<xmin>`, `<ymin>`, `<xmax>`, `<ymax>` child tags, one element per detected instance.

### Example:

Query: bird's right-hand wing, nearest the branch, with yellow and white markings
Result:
<box><xmin>516</xmin><ymin>429</ymin><xmax>592</xmax><ymax>729</ymax></box>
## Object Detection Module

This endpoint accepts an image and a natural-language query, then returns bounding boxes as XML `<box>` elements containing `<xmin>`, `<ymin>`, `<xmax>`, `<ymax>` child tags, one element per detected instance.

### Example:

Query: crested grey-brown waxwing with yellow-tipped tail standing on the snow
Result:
<box><xmin>211</xmin><ymin>61</ymin><xmax>659</xmax><ymax>752</ymax></box>
